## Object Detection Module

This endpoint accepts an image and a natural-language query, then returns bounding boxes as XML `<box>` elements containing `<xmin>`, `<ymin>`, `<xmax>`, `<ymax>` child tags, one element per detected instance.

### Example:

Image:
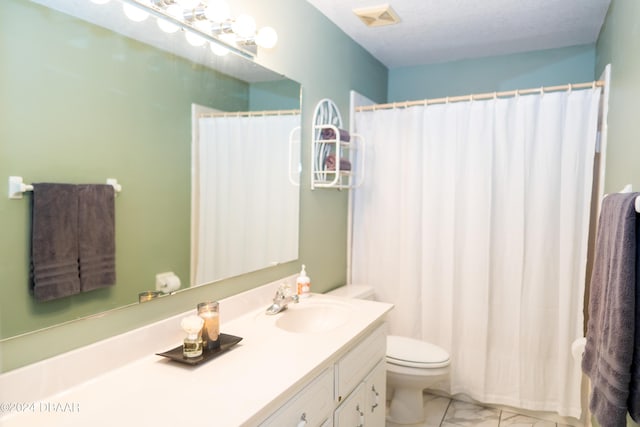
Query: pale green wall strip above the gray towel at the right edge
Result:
<box><xmin>594</xmin><ymin>0</ymin><xmax>640</xmax><ymax>426</ymax></box>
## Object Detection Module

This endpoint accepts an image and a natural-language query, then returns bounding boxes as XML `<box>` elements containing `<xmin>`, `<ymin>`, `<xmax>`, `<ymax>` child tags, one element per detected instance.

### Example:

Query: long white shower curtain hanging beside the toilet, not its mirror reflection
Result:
<box><xmin>352</xmin><ymin>89</ymin><xmax>600</xmax><ymax>417</ymax></box>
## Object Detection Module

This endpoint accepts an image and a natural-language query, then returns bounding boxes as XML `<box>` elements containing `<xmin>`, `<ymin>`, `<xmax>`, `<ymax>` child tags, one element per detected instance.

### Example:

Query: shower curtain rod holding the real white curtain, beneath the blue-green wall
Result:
<box><xmin>355</xmin><ymin>80</ymin><xmax>605</xmax><ymax>111</ymax></box>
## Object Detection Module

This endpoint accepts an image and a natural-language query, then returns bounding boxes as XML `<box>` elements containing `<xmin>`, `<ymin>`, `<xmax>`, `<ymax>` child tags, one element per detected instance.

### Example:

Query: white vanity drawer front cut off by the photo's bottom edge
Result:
<box><xmin>260</xmin><ymin>368</ymin><xmax>334</xmax><ymax>427</ymax></box>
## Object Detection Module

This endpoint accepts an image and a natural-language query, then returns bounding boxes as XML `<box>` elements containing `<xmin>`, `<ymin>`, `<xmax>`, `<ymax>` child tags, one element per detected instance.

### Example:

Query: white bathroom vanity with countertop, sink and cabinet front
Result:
<box><xmin>0</xmin><ymin>282</ymin><xmax>392</xmax><ymax>427</ymax></box>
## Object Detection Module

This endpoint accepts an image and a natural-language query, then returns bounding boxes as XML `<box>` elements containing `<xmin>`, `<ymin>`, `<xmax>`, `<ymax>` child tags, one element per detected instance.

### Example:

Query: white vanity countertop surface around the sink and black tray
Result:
<box><xmin>0</xmin><ymin>294</ymin><xmax>392</xmax><ymax>427</ymax></box>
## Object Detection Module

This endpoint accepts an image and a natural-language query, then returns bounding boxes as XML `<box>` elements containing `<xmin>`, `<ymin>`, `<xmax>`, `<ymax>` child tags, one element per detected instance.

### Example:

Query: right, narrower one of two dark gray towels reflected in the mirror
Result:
<box><xmin>78</xmin><ymin>184</ymin><xmax>116</xmax><ymax>292</ymax></box>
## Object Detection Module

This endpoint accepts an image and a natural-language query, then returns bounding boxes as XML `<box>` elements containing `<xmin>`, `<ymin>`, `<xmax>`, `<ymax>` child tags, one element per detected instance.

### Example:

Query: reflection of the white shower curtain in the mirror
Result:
<box><xmin>192</xmin><ymin>115</ymin><xmax>300</xmax><ymax>284</ymax></box>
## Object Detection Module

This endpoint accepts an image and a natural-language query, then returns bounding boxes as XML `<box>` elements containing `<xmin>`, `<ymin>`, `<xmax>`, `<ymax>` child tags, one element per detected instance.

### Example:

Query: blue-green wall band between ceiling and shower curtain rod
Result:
<box><xmin>388</xmin><ymin>45</ymin><xmax>595</xmax><ymax>102</ymax></box>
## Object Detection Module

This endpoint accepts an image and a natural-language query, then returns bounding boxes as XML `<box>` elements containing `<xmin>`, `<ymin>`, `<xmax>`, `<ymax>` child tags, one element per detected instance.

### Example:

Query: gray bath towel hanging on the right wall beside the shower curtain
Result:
<box><xmin>582</xmin><ymin>193</ymin><xmax>639</xmax><ymax>427</ymax></box>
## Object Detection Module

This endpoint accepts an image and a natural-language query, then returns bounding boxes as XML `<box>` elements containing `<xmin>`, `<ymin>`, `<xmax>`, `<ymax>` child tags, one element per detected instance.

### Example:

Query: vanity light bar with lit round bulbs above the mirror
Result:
<box><xmin>91</xmin><ymin>0</ymin><xmax>278</xmax><ymax>58</ymax></box>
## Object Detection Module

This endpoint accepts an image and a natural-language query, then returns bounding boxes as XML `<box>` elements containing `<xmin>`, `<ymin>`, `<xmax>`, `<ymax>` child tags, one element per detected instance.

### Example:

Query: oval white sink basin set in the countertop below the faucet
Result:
<box><xmin>275</xmin><ymin>300</ymin><xmax>351</xmax><ymax>333</ymax></box>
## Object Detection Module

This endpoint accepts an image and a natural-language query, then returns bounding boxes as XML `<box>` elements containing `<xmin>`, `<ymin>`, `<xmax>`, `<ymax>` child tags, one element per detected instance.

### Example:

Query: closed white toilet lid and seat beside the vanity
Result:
<box><xmin>387</xmin><ymin>335</ymin><xmax>449</xmax><ymax>368</ymax></box>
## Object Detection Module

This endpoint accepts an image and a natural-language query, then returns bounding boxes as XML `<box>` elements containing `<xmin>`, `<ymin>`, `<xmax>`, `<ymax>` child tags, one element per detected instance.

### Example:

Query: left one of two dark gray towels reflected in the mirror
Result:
<box><xmin>31</xmin><ymin>183</ymin><xmax>80</xmax><ymax>301</ymax></box>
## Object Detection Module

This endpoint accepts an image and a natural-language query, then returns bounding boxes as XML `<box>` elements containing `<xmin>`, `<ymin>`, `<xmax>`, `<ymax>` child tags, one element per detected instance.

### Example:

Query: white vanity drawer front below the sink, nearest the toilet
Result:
<box><xmin>334</xmin><ymin>323</ymin><xmax>387</xmax><ymax>402</ymax></box>
